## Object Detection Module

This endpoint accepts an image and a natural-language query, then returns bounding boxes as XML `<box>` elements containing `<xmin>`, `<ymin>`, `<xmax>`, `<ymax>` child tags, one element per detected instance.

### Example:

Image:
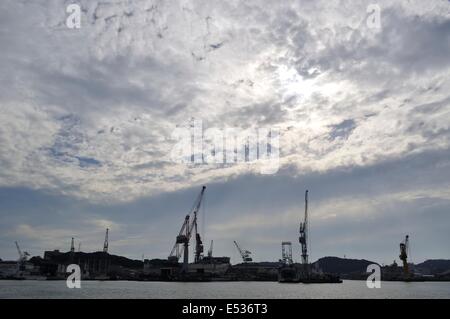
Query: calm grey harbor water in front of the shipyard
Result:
<box><xmin>0</xmin><ymin>280</ymin><xmax>450</xmax><ymax>299</ymax></box>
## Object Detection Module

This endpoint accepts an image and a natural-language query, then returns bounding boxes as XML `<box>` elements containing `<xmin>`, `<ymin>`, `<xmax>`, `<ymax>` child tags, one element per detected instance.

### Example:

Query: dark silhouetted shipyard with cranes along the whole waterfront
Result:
<box><xmin>0</xmin><ymin>186</ymin><xmax>450</xmax><ymax>284</ymax></box>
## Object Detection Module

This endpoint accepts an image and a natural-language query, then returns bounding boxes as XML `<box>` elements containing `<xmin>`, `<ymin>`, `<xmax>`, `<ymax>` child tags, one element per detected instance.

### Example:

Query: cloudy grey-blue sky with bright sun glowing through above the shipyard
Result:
<box><xmin>0</xmin><ymin>0</ymin><xmax>450</xmax><ymax>264</ymax></box>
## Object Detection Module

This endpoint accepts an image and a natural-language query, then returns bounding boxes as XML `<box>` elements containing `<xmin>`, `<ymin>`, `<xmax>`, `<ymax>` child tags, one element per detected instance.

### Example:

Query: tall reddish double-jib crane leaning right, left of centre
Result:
<box><xmin>168</xmin><ymin>186</ymin><xmax>206</xmax><ymax>272</ymax></box>
